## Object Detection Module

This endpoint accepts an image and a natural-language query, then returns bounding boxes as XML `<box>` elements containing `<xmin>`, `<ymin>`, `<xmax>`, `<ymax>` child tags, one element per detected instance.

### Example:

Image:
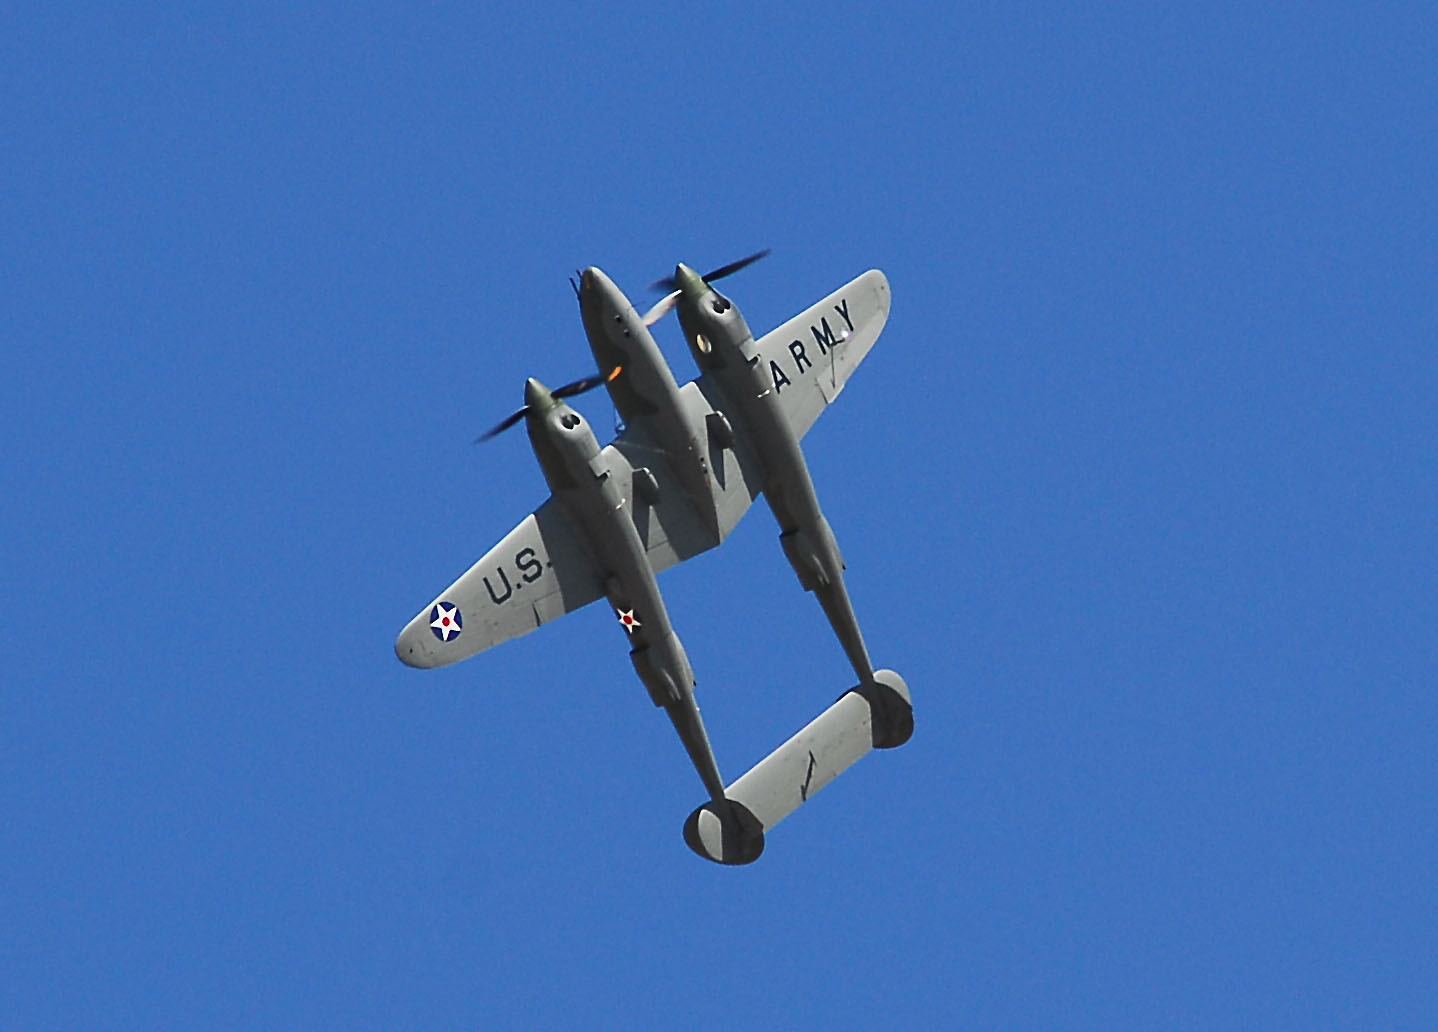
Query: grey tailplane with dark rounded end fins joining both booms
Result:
<box><xmin>684</xmin><ymin>670</ymin><xmax>913</xmax><ymax>864</ymax></box>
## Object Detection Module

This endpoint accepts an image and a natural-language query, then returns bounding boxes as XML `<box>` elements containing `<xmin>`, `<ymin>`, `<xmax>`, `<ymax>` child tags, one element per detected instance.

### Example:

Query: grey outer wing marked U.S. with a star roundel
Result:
<box><xmin>394</xmin><ymin>497</ymin><xmax>604</xmax><ymax>667</ymax></box>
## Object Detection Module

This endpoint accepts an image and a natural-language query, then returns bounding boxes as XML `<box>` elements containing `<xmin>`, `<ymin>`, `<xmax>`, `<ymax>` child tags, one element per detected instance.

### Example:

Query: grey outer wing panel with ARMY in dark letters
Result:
<box><xmin>755</xmin><ymin>269</ymin><xmax>889</xmax><ymax>438</ymax></box>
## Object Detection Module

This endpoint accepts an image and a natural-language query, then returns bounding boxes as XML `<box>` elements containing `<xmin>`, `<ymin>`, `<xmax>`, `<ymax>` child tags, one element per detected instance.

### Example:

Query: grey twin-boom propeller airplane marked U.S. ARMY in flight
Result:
<box><xmin>394</xmin><ymin>252</ymin><xmax>913</xmax><ymax>864</ymax></box>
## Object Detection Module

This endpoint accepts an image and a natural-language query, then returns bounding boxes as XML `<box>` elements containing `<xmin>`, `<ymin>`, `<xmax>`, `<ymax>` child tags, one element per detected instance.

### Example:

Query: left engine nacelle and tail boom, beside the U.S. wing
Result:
<box><xmin>525</xmin><ymin>378</ymin><xmax>723</xmax><ymax>801</ymax></box>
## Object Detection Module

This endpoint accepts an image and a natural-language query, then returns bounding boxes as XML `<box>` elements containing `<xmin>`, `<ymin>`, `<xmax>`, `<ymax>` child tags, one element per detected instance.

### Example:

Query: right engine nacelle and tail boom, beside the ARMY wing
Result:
<box><xmin>674</xmin><ymin>263</ymin><xmax>874</xmax><ymax>684</ymax></box>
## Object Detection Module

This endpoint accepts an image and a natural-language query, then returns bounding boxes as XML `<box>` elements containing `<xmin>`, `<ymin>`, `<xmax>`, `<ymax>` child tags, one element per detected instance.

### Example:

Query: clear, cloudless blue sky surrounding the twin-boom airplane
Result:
<box><xmin>0</xmin><ymin>3</ymin><xmax>1438</xmax><ymax>1029</ymax></box>
